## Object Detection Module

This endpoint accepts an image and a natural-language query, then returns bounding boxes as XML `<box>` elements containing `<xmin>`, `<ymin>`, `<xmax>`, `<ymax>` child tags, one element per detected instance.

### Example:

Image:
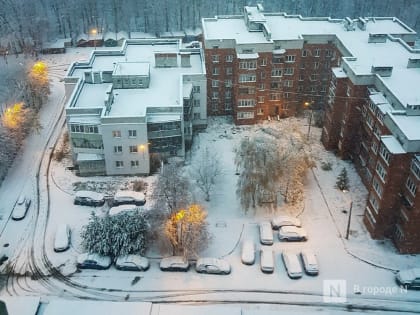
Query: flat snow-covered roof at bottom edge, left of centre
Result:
<box><xmin>44</xmin><ymin>299</ymin><xmax>152</xmax><ymax>315</ymax></box>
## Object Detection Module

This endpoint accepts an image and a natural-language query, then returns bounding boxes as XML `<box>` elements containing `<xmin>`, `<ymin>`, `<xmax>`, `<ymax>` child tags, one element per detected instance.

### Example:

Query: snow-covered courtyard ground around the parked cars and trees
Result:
<box><xmin>0</xmin><ymin>49</ymin><xmax>420</xmax><ymax>314</ymax></box>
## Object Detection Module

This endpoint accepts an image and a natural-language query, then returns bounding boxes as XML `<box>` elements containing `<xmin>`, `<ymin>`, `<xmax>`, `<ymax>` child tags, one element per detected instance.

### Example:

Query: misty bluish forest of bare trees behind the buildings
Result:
<box><xmin>0</xmin><ymin>0</ymin><xmax>420</xmax><ymax>52</ymax></box>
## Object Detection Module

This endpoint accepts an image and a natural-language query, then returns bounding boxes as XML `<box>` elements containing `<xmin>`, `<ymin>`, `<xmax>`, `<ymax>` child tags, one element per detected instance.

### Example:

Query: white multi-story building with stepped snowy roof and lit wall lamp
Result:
<box><xmin>65</xmin><ymin>39</ymin><xmax>207</xmax><ymax>175</ymax></box>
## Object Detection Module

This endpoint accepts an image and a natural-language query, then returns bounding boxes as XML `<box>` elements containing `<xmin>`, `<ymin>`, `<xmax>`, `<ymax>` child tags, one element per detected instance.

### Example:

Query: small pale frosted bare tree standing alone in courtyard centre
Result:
<box><xmin>191</xmin><ymin>147</ymin><xmax>222</xmax><ymax>201</ymax></box>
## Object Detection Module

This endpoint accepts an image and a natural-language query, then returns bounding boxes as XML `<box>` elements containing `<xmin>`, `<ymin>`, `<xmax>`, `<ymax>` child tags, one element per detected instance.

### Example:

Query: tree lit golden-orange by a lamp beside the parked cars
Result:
<box><xmin>165</xmin><ymin>204</ymin><xmax>211</xmax><ymax>258</ymax></box>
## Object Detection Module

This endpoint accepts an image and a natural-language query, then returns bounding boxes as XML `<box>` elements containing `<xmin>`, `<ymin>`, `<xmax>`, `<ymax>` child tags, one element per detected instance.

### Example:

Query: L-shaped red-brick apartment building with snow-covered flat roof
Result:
<box><xmin>202</xmin><ymin>5</ymin><xmax>420</xmax><ymax>253</ymax></box>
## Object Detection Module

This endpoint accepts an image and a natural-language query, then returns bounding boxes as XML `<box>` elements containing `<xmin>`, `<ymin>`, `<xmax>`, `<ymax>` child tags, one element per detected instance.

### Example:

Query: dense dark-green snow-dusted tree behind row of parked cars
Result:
<box><xmin>81</xmin><ymin>211</ymin><xmax>149</xmax><ymax>258</ymax></box>
